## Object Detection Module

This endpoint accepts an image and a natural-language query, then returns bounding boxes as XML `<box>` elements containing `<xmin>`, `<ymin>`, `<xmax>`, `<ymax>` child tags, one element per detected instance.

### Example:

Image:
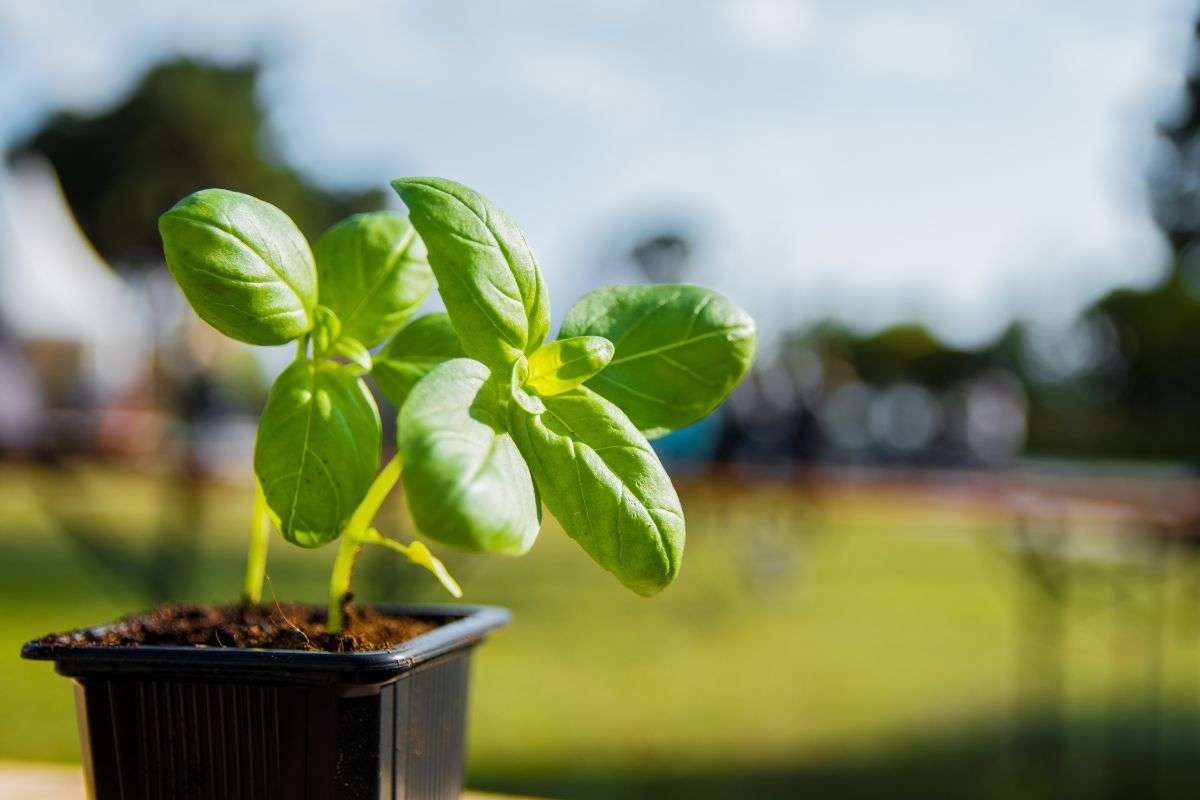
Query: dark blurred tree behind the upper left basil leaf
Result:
<box><xmin>13</xmin><ymin>60</ymin><xmax>383</xmax><ymax>269</ymax></box>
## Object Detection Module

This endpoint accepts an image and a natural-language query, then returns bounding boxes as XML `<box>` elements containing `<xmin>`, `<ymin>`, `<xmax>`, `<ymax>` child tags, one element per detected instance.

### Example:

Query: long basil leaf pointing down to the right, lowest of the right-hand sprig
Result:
<box><xmin>509</xmin><ymin>386</ymin><xmax>684</xmax><ymax>596</ymax></box>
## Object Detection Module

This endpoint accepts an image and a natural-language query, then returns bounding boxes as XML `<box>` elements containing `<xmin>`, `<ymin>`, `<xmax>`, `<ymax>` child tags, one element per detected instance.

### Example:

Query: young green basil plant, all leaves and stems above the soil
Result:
<box><xmin>160</xmin><ymin>178</ymin><xmax>755</xmax><ymax>632</ymax></box>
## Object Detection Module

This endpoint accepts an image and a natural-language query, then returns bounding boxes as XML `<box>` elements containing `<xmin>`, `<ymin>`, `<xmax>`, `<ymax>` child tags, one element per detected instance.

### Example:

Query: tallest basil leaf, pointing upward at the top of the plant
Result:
<box><xmin>391</xmin><ymin>178</ymin><xmax>550</xmax><ymax>371</ymax></box>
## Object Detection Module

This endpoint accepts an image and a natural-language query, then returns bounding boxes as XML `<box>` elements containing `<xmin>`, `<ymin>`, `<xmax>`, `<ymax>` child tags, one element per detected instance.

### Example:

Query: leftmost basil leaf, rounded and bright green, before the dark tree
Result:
<box><xmin>158</xmin><ymin>188</ymin><xmax>317</xmax><ymax>344</ymax></box>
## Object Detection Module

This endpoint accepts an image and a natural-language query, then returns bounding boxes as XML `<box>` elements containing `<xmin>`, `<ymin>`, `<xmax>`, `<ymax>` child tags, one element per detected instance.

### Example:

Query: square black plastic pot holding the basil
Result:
<box><xmin>20</xmin><ymin>606</ymin><xmax>509</xmax><ymax>800</ymax></box>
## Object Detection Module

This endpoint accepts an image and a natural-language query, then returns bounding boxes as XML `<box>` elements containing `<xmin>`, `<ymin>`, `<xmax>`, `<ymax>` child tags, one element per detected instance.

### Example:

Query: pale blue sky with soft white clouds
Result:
<box><xmin>0</xmin><ymin>0</ymin><xmax>1195</xmax><ymax>345</ymax></box>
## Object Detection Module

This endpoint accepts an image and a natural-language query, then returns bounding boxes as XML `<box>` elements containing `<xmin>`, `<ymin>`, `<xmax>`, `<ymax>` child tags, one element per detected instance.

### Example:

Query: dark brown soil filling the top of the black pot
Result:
<box><xmin>41</xmin><ymin>603</ymin><xmax>438</xmax><ymax>652</ymax></box>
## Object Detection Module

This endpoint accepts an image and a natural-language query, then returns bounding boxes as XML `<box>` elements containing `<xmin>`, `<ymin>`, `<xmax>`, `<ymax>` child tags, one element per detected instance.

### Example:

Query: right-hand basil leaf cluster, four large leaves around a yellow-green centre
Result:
<box><xmin>392</xmin><ymin>178</ymin><xmax>755</xmax><ymax>595</ymax></box>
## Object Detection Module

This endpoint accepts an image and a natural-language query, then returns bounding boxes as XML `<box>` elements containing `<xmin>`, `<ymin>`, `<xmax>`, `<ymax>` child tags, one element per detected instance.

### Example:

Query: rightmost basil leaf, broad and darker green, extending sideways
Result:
<box><xmin>559</xmin><ymin>285</ymin><xmax>756</xmax><ymax>439</ymax></box>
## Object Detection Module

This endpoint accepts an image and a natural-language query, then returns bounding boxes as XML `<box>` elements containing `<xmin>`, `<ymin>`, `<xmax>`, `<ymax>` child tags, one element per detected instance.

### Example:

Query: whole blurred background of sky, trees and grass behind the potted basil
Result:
<box><xmin>0</xmin><ymin>0</ymin><xmax>1200</xmax><ymax>800</ymax></box>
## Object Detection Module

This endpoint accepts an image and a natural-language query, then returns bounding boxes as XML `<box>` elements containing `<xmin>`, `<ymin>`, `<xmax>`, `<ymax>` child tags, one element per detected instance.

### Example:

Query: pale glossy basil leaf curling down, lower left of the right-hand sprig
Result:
<box><xmin>397</xmin><ymin>359</ymin><xmax>541</xmax><ymax>555</ymax></box>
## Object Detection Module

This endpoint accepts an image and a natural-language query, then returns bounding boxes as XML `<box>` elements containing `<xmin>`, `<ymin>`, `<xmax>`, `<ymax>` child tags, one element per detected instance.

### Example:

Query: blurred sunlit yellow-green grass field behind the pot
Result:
<box><xmin>0</xmin><ymin>467</ymin><xmax>1200</xmax><ymax>798</ymax></box>
